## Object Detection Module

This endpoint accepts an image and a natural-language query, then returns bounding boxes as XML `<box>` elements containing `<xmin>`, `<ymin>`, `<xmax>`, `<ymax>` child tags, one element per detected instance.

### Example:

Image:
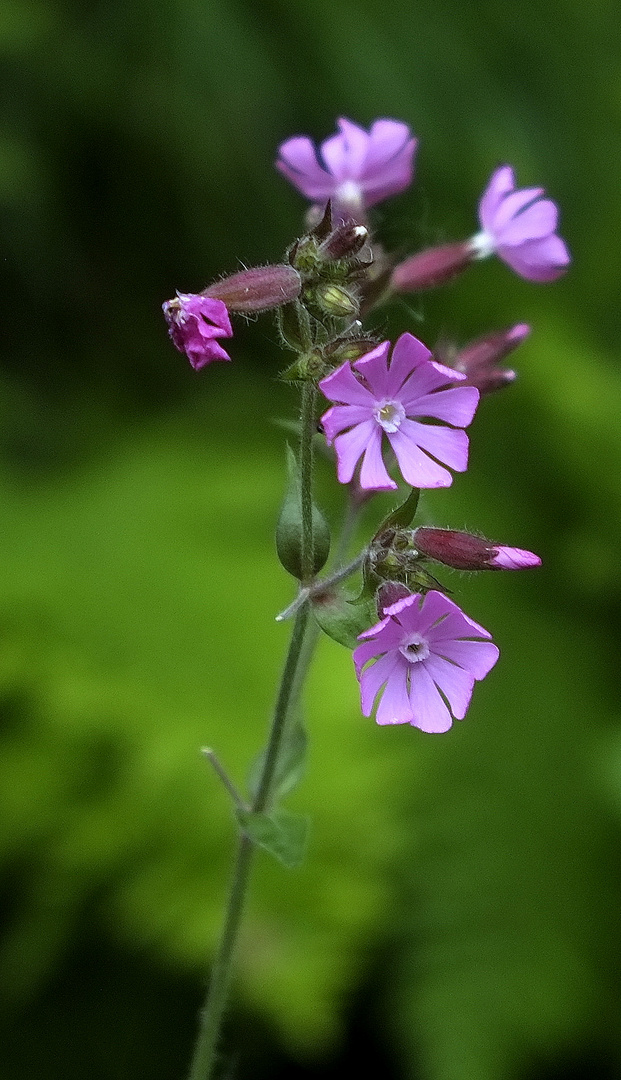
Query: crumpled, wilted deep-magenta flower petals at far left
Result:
<box><xmin>162</xmin><ymin>293</ymin><xmax>233</xmax><ymax>372</ymax></box>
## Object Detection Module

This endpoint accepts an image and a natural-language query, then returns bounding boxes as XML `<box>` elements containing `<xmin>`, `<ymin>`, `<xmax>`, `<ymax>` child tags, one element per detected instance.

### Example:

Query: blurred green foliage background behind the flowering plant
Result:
<box><xmin>0</xmin><ymin>0</ymin><xmax>621</xmax><ymax>1080</ymax></box>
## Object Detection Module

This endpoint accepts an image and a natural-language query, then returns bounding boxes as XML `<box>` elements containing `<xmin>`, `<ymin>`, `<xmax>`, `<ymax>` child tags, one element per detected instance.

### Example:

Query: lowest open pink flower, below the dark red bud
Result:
<box><xmin>353</xmin><ymin>591</ymin><xmax>499</xmax><ymax>732</ymax></box>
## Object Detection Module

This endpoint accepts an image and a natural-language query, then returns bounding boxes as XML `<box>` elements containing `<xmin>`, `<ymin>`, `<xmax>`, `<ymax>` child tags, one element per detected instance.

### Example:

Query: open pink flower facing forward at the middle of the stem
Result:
<box><xmin>319</xmin><ymin>334</ymin><xmax>478</xmax><ymax>490</ymax></box>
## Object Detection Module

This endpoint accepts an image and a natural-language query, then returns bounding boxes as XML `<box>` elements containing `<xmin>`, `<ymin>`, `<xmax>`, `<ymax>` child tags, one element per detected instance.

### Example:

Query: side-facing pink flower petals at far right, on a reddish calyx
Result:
<box><xmin>471</xmin><ymin>165</ymin><xmax>570</xmax><ymax>282</ymax></box>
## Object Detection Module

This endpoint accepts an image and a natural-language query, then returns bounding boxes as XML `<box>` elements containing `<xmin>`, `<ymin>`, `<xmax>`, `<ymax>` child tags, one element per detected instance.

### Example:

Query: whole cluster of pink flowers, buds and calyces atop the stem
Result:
<box><xmin>163</xmin><ymin>118</ymin><xmax>557</xmax><ymax>732</ymax></box>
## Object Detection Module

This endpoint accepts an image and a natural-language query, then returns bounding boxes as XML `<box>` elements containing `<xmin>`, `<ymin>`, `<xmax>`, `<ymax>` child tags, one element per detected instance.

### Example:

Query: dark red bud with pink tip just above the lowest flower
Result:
<box><xmin>411</xmin><ymin>526</ymin><xmax>541</xmax><ymax>570</ymax></box>
